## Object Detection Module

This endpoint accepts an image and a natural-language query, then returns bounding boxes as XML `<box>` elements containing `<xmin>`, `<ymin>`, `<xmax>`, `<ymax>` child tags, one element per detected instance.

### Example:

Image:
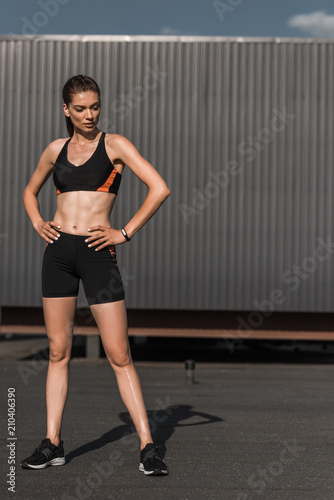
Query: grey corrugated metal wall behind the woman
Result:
<box><xmin>0</xmin><ymin>36</ymin><xmax>334</xmax><ymax>312</ymax></box>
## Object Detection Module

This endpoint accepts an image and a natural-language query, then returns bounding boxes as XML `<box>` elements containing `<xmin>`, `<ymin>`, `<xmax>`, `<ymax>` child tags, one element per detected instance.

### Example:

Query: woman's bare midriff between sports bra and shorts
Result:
<box><xmin>53</xmin><ymin>191</ymin><xmax>116</xmax><ymax>236</ymax></box>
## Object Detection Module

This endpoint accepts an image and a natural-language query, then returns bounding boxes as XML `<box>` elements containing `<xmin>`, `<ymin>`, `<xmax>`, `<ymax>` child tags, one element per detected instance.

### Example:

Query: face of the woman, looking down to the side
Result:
<box><xmin>63</xmin><ymin>90</ymin><xmax>101</xmax><ymax>132</ymax></box>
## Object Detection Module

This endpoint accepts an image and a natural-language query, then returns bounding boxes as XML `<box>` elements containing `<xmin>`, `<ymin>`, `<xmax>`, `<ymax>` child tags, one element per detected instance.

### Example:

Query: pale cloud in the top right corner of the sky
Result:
<box><xmin>287</xmin><ymin>11</ymin><xmax>334</xmax><ymax>37</ymax></box>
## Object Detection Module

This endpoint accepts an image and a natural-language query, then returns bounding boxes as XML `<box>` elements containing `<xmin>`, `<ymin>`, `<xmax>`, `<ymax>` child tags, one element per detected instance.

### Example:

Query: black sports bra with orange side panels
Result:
<box><xmin>53</xmin><ymin>132</ymin><xmax>122</xmax><ymax>195</ymax></box>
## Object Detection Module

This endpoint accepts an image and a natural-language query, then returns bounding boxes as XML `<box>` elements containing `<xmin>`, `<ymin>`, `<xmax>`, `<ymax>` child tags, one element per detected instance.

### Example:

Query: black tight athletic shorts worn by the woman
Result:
<box><xmin>42</xmin><ymin>230</ymin><xmax>125</xmax><ymax>305</ymax></box>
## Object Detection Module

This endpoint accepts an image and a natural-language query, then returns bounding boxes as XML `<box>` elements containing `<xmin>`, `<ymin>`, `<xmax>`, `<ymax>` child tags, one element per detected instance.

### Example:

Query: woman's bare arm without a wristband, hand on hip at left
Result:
<box><xmin>22</xmin><ymin>141</ymin><xmax>60</xmax><ymax>243</ymax></box>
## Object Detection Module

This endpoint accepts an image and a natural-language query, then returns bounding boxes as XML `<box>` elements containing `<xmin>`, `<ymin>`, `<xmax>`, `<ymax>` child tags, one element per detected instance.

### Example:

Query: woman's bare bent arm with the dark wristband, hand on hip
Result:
<box><xmin>86</xmin><ymin>134</ymin><xmax>171</xmax><ymax>250</ymax></box>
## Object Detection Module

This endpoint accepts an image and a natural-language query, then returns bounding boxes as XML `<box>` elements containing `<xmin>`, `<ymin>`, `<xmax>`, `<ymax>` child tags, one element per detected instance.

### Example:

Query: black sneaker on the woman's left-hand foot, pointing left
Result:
<box><xmin>20</xmin><ymin>438</ymin><xmax>65</xmax><ymax>469</ymax></box>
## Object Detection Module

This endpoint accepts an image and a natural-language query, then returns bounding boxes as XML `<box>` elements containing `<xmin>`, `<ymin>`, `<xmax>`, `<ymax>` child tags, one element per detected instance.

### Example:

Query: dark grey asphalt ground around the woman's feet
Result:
<box><xmin>0</xmin><ymin>337</ymin><xmax>334</xmax><ymax>500</ymax></box>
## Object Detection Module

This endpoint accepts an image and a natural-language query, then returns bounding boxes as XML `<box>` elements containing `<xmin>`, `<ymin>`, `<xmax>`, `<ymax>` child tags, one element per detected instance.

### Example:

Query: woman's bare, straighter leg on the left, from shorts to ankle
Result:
<box><xmin>43</xmin><ymin>297</ymin><xmax>77</xmax><ymax>446</ymax></box>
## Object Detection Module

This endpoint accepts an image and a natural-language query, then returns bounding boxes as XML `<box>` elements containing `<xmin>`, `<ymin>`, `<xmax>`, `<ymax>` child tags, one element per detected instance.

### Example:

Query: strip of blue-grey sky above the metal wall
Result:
<box><xmin>0</xmin><ymin>0</ymin><xmax>334</xmax><ymax>38</ymax></box>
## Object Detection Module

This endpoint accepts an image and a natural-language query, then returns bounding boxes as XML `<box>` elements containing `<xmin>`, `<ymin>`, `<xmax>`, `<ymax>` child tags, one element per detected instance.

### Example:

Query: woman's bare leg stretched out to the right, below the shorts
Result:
<box><xmin>90</xmin><ymin>300</ymin><xmax>153</xmax><ymax>449</ymax></box>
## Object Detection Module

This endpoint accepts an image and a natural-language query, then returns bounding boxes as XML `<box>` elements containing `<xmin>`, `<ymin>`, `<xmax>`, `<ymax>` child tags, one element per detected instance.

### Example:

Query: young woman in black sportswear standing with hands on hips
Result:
<box><xmin>21</xmin><ymin>75</ymin><xmax>170</xmax><ymax>475</ymax></box>
